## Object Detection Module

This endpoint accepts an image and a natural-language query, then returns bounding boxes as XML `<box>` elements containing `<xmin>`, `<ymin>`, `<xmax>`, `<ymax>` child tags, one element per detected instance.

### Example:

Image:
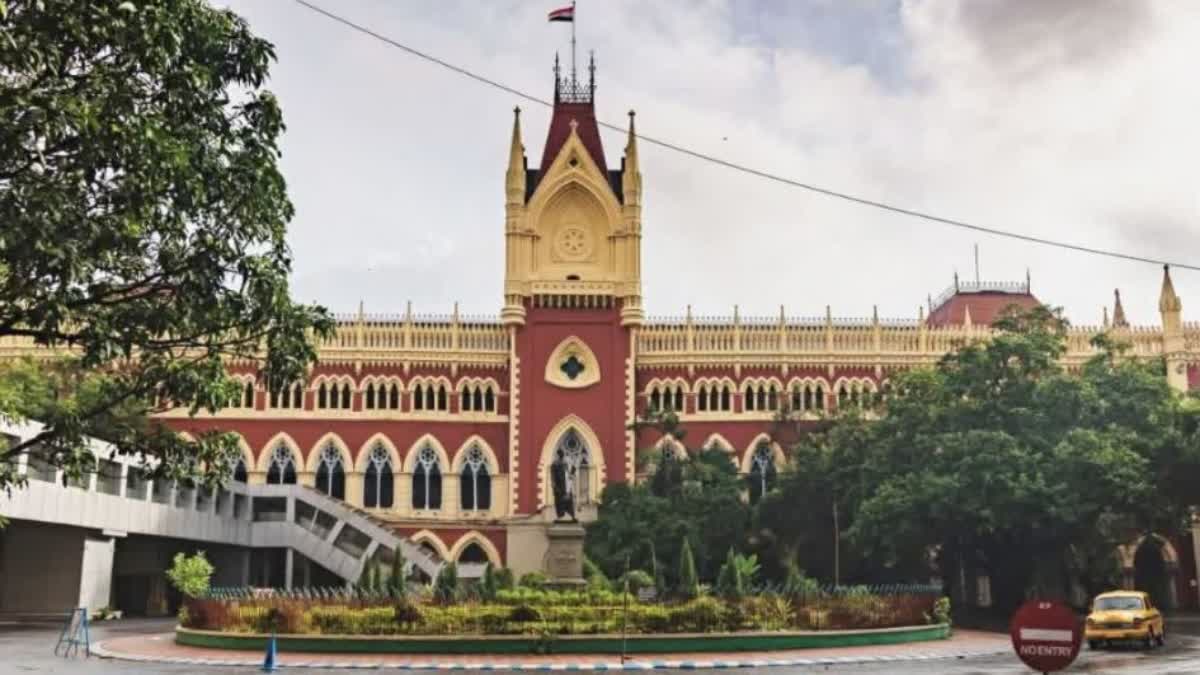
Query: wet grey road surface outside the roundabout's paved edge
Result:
<box><xmin>7</xmin><ymin>617</ymin><xmax>1200</xmax><ymax>675</ymax></box>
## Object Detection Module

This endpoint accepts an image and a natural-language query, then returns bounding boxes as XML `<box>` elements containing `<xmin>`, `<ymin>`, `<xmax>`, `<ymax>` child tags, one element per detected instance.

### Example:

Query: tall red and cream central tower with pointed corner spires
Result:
<box><xmin>500</xmin><ymin>59</ymin><xmax>643</xmax><ymax>530</ymax></box>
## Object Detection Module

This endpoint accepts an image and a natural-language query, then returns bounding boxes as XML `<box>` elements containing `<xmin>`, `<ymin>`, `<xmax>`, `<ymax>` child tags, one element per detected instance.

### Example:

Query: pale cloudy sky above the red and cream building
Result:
<box><xmin>222</xmin><ymin>0</ymin><xmax>1200</xmax><ymax>324</ymax></box>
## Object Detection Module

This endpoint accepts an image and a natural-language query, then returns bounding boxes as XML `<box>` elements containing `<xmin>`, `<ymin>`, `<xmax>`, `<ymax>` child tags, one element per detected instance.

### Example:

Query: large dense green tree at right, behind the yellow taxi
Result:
<box><xmin>760</xmin><ymin>307</ymin><xmax>1200</xmax><ymax>608</ymax></box>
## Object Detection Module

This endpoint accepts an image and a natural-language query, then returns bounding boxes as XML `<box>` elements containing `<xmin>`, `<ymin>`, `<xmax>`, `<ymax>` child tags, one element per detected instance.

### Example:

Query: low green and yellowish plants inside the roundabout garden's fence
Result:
<box><xmin>180</xmin><ymin>587</ymin><xmax>948</xmax><ymax>639</ymax></box>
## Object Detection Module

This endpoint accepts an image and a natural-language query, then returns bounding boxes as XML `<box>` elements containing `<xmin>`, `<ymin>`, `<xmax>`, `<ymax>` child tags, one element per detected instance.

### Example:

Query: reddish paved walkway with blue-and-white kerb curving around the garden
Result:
<box><xmin>92</xmin><ymin>631</ymin><xmax>1012</xmax><ymax>671</ymax></box>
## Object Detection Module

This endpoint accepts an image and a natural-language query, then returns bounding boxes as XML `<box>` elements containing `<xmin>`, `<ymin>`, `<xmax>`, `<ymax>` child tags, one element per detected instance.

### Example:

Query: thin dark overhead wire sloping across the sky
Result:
<box><xmin>285</xmin><ymin>0</ymin><xmax>1200</xmax><ymax>271</ymax></box>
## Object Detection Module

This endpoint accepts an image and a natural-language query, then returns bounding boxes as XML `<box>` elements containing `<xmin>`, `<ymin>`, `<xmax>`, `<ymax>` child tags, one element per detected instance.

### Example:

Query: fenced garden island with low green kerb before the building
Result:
<box><xmin>175</xmin><ymin>565</ymin><xmax>950</xmax><ymax>655</ymax></box>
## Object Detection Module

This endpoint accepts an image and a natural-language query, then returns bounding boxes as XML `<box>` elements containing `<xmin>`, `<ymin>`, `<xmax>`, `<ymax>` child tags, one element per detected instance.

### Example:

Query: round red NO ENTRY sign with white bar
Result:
<box><xmin>1009</xmin><ymin>601</ymin><xmax>1084</xmax><ymax>673</ymax></box>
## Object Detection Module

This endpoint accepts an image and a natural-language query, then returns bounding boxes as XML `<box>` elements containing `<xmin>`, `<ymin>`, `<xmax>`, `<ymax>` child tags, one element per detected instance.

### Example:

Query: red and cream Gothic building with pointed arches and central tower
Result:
<box><xmin>145</xmin><ymin>64</ymin><xmax>1200</xmax><ymax>604</ymax></box>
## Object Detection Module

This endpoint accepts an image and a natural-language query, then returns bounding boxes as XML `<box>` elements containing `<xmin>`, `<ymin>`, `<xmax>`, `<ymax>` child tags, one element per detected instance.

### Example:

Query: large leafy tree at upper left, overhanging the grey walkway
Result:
<box><xmin>0</xmin><ymin>0</ymin><xmax>331</xmax><ymax>488</ymax></box>
